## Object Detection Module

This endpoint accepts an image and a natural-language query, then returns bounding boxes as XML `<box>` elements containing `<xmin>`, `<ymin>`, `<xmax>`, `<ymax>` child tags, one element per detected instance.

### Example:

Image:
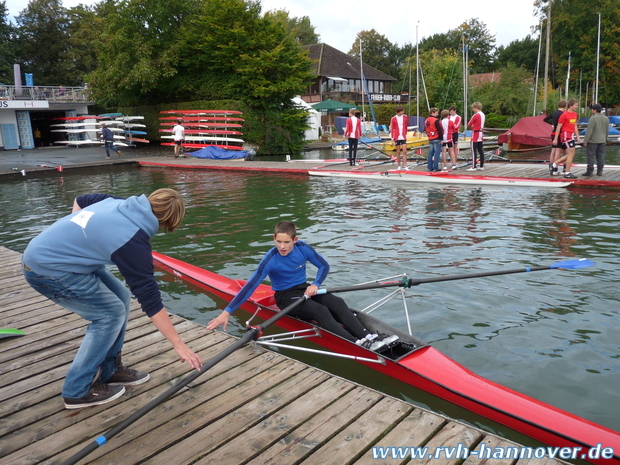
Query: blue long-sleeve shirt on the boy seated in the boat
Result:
<box><xmin>224</xmin><ymin>241</ymin><xmax>329</xmax><ymax>313</ymax></box>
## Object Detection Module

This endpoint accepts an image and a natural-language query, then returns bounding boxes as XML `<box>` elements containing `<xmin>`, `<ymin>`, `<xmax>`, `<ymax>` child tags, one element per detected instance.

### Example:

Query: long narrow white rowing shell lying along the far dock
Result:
<box><xmin>308</xmin><ymin>171</ymin><xmax>572</xmax><ymax>189</ymax></box>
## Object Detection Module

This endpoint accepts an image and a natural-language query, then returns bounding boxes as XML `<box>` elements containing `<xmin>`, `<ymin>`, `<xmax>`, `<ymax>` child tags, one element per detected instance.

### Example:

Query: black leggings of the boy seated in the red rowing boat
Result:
<box><xmin>275</xmin><ymin>283</ymin><xmax>368</xmax><ymax>342</ymax></box>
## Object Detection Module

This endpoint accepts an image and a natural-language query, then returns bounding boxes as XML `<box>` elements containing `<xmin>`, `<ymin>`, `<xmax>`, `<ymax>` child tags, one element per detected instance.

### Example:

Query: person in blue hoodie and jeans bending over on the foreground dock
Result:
<box><xmin>22</xmin><ymin>189</ymin><xmax>202</xmax><ymax>409</ymax></box>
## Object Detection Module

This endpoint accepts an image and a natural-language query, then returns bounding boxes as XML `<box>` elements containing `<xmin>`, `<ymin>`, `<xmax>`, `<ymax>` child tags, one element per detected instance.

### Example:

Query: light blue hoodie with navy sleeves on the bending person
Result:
<box><xmin>23</xmin><ymin>194</ymin><xmax>164</xmax><ymax>316</ymax></box>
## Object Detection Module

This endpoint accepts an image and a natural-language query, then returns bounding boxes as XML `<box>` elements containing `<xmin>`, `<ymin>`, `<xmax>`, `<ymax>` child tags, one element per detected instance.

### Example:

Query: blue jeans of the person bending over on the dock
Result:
<box><xmin>23</xmin><ymin>264</ymin><xmax>131</xmax><ymax>399</ymax></box>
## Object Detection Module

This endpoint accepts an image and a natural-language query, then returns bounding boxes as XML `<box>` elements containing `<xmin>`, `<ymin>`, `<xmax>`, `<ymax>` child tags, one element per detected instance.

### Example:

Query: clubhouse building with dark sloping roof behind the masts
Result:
<box><xmin>301</xmin><ymin>44</ymin><xmax>405</xmax><ymax>104</ymax></box>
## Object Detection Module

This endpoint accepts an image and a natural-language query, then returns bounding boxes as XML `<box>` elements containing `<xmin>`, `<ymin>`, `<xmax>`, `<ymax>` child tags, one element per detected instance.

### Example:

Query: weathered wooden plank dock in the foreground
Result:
<box><xmin>0</xmin><ymin>247</ymin><xmax>564</xmax><ymax>465</ymax></box>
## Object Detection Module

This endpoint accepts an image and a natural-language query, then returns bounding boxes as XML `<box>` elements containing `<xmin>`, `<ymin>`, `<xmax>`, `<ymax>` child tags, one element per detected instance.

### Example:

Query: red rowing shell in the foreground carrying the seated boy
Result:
<box><xmin>153</xmin><ymin>252</ymin><xmax>620</xmax><ymax>464</ymax></box>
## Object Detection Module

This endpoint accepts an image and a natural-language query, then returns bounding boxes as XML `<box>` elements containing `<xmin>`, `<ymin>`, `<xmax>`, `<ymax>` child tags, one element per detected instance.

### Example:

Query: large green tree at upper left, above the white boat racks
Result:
<box><xmin>87</xmin><ymin>0</ymin><xmax>199</xmax><ymax>105</ymax></box>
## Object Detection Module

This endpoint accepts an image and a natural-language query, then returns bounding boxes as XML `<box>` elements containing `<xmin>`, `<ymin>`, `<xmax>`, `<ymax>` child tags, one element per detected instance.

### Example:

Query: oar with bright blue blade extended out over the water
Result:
<box><xmin>317</xmin><ymin>258</ymin><xmax>595</xmax><ymax>294</ymax></box>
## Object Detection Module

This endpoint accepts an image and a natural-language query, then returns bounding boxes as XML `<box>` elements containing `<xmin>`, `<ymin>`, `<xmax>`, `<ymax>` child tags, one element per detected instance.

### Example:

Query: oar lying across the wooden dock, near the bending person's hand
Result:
<box><xmin>62</xmin><ymin>296</ymin><xmax>307</xmax><ymax>465</ymax></box>
